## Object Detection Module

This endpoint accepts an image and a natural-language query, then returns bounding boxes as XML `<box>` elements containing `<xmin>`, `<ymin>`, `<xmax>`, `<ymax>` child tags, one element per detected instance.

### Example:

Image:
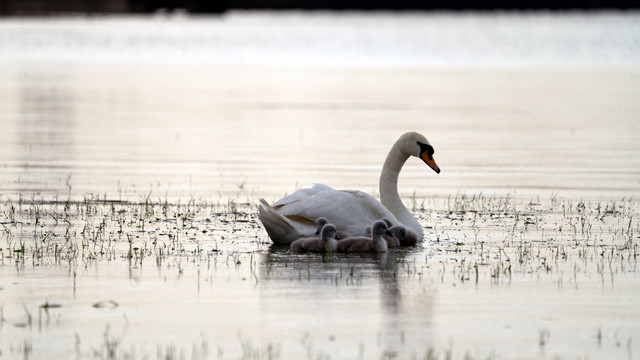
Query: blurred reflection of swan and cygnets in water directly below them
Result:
<box><xmin>258</xmin><ymin>246</ymin><xmax>434</xmax><ymax>355</ymax></box>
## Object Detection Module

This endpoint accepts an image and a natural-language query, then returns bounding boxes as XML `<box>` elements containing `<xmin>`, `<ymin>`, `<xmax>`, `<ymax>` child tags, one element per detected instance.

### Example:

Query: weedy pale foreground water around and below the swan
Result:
<box><xmin>0</xmin><ymin>196</ymin><xmax>640</xmax><ymax>359</ymax></box>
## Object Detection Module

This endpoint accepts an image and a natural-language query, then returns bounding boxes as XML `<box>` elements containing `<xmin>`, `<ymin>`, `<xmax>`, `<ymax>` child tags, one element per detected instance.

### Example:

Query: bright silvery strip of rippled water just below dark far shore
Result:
<box><xmin>0</xmin><ymin>12</ymin><xmax>640</xmax><ymax>67</ymax></box>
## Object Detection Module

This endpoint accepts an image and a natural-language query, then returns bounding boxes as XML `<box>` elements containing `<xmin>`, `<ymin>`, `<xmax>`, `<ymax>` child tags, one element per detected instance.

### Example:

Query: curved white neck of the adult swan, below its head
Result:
<box><xmin>380</xmin><ymin>143</ymin><xmax>424</xmax><ymax>239</ymax></box>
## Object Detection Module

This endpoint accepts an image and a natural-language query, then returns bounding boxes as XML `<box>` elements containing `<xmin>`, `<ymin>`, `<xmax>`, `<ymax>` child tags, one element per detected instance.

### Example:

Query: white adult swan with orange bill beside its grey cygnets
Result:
<box><xmin>258</xmin><ymin>132</ymin><xmax>440</xmax><ymax>243</ymax></box>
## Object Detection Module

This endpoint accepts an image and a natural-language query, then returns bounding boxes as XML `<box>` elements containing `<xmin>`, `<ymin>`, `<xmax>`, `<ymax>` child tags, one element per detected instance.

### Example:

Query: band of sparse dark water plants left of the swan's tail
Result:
<box><xmin>0</xmin><ymin>193</ymin><xmax>268</xmax><ymax>267</ymax></box>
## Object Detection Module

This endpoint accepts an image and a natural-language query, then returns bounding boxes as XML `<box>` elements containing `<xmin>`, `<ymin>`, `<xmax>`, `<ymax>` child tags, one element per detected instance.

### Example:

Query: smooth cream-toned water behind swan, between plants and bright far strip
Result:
<box><xmin>0</xmin><ymin>64</ymin><xmax>640</xmax><ymax>200</ymax></box>
